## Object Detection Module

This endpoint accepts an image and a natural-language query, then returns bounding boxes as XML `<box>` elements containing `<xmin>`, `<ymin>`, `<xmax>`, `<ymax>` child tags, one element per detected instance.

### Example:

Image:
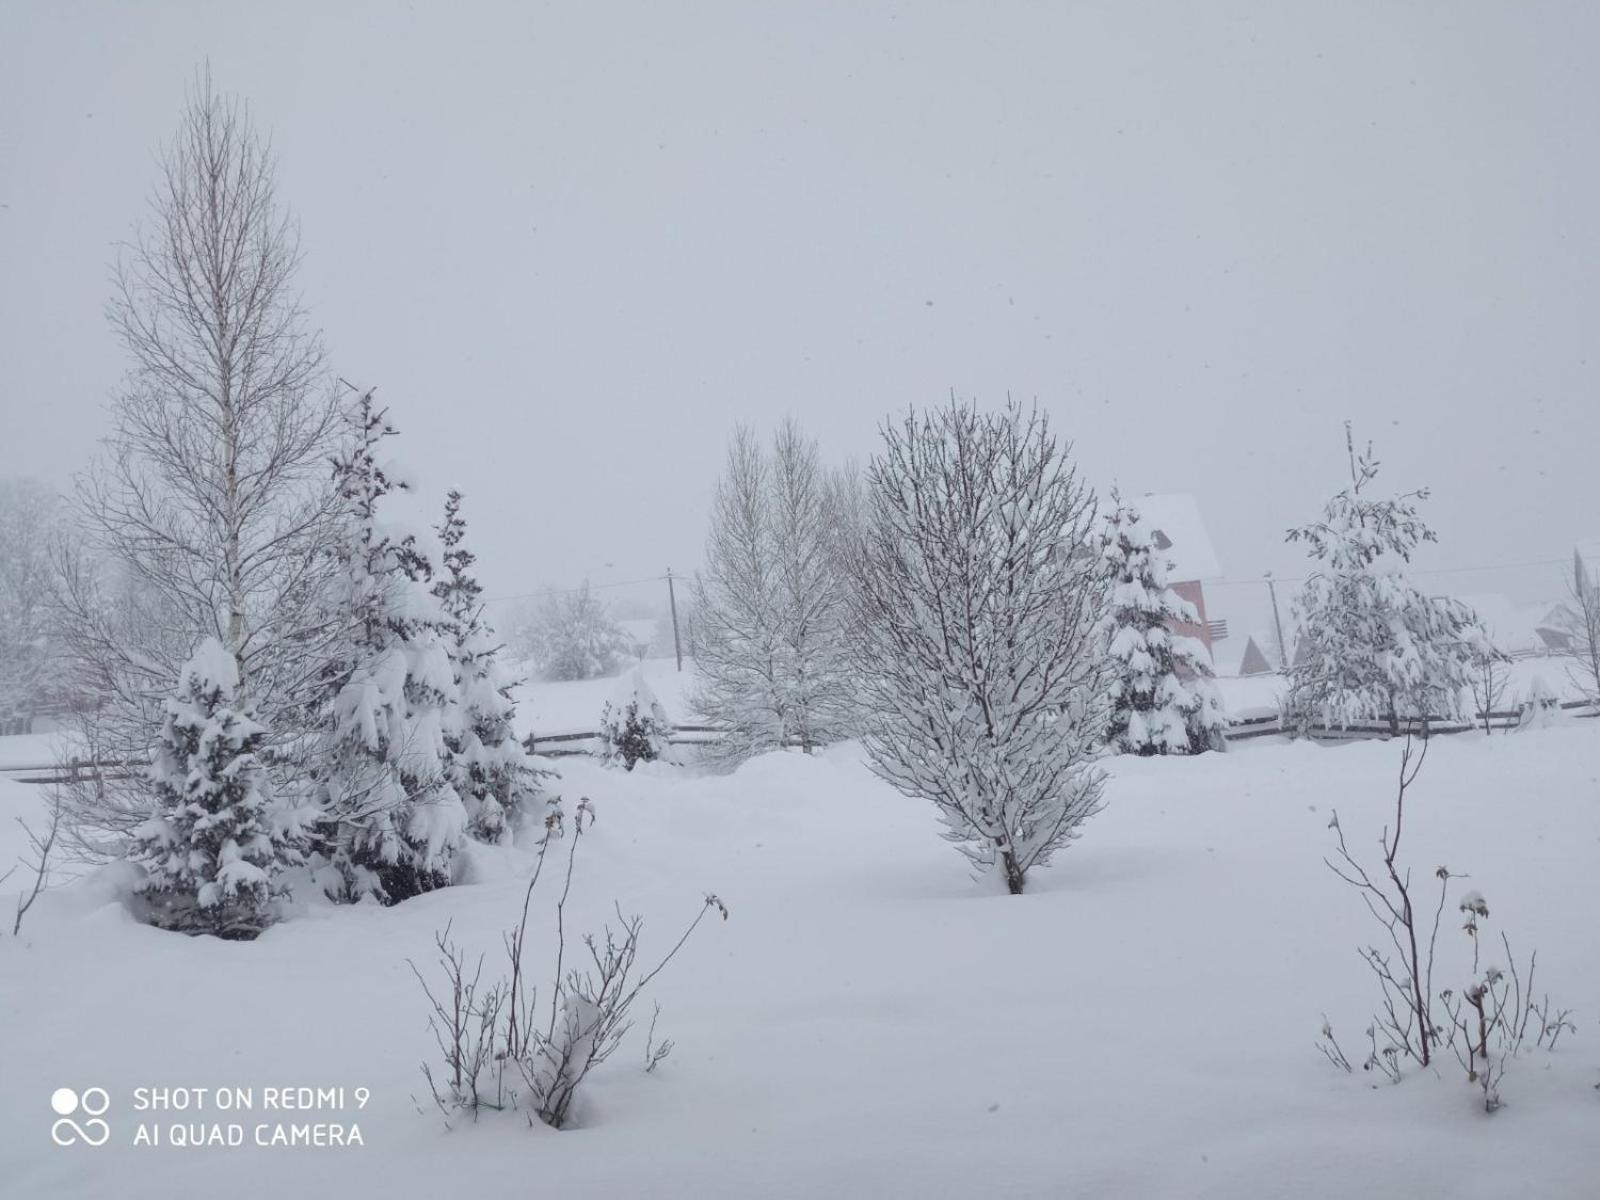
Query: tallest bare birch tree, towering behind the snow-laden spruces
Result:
<box><xmin>54</xmin><ymin>75</ymin><xmax>338</xmax><ymax>858</ymax></box>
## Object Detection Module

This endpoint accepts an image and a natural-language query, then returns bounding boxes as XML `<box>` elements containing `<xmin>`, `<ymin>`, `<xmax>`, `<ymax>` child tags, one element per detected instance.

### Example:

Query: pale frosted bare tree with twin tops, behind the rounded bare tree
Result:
<box><xmin>693</xmin><ymin>421</ymin><xmax>854</xmax><ymax>765</ymax></box>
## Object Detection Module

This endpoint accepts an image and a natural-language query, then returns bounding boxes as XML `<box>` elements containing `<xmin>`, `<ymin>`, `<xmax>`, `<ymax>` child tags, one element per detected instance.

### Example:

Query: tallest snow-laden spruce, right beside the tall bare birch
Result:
<box><xmin>312</xmin><ymin>392</ymin><xmax>467</xmax><ymax>904</ymax></box>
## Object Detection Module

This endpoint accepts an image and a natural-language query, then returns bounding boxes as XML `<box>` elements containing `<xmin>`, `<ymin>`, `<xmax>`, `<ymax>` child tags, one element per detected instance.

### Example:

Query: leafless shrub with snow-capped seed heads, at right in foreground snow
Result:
<box><xmin>1317</xmin><ymin>734</ymin><xmax>1574</xmax><ymax>1112</ymax></box>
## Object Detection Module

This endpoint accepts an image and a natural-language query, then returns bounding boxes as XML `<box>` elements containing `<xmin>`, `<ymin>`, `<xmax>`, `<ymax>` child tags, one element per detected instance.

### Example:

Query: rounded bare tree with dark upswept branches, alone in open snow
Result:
<box><xmin>854</xmin><ymin>398</ymin><xmax>1109</xmax><ymax>894</ymax></box>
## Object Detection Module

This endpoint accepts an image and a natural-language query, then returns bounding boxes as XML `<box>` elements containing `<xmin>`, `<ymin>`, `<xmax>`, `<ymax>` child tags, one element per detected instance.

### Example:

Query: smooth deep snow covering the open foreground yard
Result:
<box><xmin>0</xmin><ymin>720</ymin><xmax>1600</xmax><ymax>1200</ymax></box>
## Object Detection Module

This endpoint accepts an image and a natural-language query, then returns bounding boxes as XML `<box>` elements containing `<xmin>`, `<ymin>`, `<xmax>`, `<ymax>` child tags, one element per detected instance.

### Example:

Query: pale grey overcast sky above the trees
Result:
<box><xmin>0</xmin><ymin>0</ymin><xmax>1600</xmax><ymax>640</ymax></box>
